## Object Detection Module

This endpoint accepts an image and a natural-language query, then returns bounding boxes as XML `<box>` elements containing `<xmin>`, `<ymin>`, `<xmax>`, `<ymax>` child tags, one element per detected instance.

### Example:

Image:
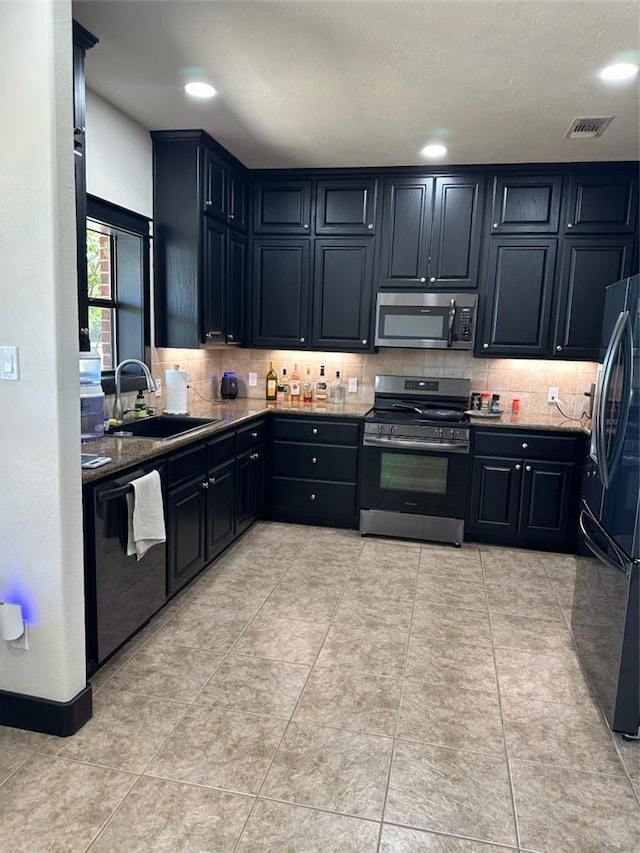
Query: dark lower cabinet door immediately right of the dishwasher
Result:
<box><xmin>167</xmin><ymin>476</ymin><xmax>206</xmax><ymax>595</ymax></box>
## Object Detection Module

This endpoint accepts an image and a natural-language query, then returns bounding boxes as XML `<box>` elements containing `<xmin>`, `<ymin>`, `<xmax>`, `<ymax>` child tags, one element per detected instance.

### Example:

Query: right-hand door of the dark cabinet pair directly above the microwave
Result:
<box><xmin>429</xmin><ymin>175</ymin><xmax>484</xmax><ymax>290</ymax></box>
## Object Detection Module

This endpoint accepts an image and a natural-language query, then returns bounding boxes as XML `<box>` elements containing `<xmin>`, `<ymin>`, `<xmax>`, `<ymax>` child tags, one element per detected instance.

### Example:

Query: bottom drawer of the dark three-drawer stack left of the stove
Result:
<box><xmin>271</xmin><ymin>477</ymin><xmax>357</xmax><ymax>516</ymax></box>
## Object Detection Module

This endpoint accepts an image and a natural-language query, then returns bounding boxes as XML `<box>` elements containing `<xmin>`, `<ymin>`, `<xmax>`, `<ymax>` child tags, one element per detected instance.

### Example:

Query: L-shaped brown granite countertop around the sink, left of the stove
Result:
<box><xmin>82</xmin><ymin>399</ymin><xmax>371</xmax><ymax>484</ymax></box>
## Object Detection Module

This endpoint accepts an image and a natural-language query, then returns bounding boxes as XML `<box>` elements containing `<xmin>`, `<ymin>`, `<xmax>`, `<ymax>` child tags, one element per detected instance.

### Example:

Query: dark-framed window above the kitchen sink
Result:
<box><xmin>87</xmin><ymin>196</ymin><xmax>150</xmax><ymax>393</ymax></box>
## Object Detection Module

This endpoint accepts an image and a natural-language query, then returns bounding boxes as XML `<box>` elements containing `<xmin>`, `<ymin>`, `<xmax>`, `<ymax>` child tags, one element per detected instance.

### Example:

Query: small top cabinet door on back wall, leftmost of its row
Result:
<box><xmin>253</xmin><ymin>181</ymin><xmax>311</xmax><ymax>234</ymax></box>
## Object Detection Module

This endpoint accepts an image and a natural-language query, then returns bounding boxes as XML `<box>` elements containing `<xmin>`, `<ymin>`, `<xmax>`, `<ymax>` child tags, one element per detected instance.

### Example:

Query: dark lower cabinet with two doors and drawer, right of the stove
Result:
<box><xmin>465</xmin><ymin>429</ymin><xmax>584</xmax><ymax>552</ymax></box>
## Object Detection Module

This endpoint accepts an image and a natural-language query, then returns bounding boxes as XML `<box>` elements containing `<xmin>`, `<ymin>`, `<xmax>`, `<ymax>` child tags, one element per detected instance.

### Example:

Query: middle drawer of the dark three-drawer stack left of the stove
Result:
<box><xmin>273</xmin><ymin>441</ymin><xmax>358</xmax><ymax>483</ymax></box>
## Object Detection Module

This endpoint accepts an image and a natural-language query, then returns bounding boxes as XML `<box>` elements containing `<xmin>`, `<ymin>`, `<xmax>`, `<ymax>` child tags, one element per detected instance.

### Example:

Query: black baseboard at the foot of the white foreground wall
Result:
<box><xmin>0</xmin><ymin>684</ymin><xmax>93</xmax><ymax>737</ymax></box>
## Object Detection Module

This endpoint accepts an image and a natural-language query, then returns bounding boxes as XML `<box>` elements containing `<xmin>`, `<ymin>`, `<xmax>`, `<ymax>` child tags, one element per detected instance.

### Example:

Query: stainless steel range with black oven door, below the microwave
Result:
<box><xmin>360</xmin><ymin>375</ymin><xmax>471</xmax><ymax>546</ymax></box>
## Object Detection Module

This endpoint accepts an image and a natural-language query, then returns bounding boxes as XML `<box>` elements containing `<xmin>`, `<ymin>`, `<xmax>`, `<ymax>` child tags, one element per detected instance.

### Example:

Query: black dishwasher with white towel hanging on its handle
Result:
<box><xmin>84</xmin><ymin>463</ymin><xmax>167</xmax><ymax>675</ymax></box>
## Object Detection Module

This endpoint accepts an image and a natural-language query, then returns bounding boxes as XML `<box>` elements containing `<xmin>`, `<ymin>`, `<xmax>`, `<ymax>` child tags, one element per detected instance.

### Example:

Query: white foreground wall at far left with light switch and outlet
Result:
<box><xmin>0</xmin><ymin>0</ymin><xmax>86</xmax><ymax>701</ymax></box>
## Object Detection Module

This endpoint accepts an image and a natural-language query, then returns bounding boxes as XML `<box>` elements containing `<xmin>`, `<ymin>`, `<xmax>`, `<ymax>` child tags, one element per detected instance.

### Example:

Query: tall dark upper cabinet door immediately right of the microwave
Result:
<box><xmin>476</xmin><ymin>237</ymin><xmax>557</xmax><ymax>358</ymax></box>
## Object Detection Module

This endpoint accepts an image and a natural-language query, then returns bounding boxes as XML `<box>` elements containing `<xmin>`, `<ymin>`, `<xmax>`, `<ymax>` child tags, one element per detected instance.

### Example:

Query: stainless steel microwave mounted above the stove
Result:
<box><xmin>375</xmin><ymin>292</ymin><xmax>478</xmax><ymax>349</ymax></box>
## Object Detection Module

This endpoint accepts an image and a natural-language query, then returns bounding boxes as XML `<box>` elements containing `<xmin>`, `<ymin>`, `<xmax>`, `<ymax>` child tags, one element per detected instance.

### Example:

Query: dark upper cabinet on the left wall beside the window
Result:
<box><xmin>151</xmin><ymin>131</ymin><xmax>246</xmax><ymax>348</ymax></box>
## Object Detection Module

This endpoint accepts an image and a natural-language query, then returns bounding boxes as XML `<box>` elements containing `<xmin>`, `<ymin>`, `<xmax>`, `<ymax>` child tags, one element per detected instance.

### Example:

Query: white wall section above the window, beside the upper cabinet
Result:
<box><xmin>86</xmin><ymin>89</ymin><xmax>153</xmax><ymax>218</ymax></box>
